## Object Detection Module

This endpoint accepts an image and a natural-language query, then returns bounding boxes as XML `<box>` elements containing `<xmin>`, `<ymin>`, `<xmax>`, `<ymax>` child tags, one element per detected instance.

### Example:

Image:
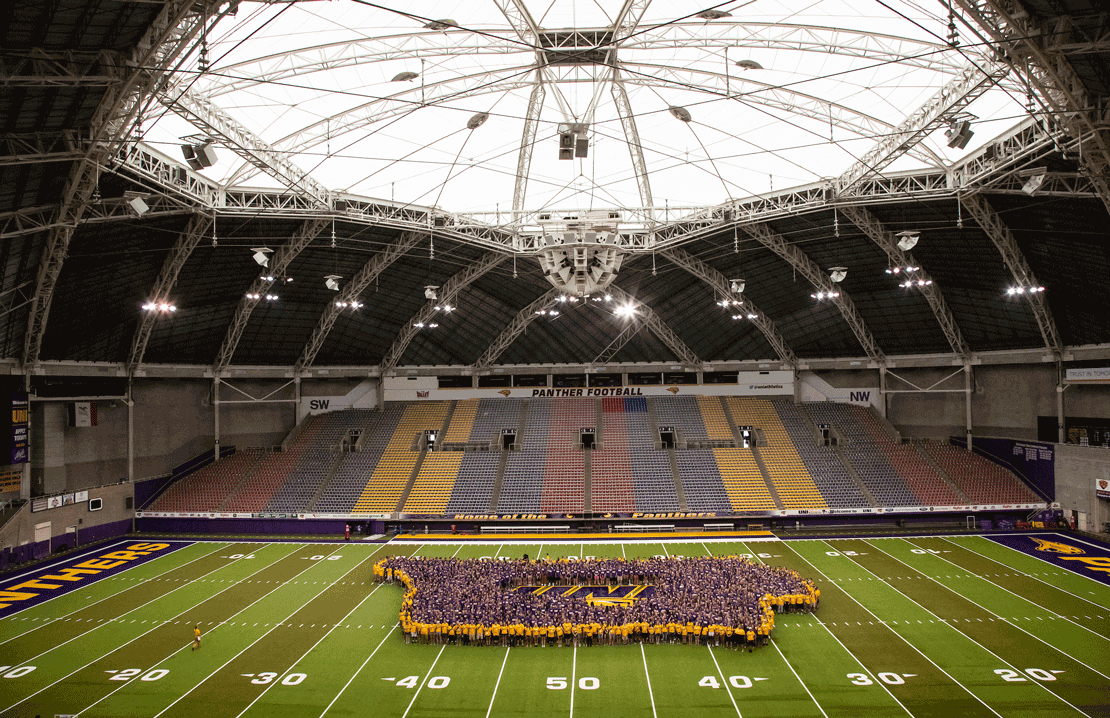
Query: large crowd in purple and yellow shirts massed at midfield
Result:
<box><xmin>374</xmin><ymin>556</ymin><xmax>820</xmax><ymax>650</ymax></box>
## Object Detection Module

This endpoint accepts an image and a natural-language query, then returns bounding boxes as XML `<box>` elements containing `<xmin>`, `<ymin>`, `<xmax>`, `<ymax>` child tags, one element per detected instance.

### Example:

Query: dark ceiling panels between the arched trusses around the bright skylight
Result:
<box><xmin>0</xmin><ymin>0</ymin><xmax>1110</xmax><ymax>377</ymax></box>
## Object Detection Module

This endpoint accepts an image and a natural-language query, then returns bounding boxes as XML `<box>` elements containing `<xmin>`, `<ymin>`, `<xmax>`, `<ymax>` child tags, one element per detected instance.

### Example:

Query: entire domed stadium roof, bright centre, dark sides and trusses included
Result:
<box><xmin>0</xmin><ymin>0</ymin><xmax>1110</xmax><ymax>372</ymax></box>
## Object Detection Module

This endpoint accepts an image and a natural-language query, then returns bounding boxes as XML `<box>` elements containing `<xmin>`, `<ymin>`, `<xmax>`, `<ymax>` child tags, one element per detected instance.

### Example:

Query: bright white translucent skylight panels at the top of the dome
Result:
<box><xmin>145</xmin><ymin>0</ymin><xmax>1025</xmax><ymax>213</ymax></box>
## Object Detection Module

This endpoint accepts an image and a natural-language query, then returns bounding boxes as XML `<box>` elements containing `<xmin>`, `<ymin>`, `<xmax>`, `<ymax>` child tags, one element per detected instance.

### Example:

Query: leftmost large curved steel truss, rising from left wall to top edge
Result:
<box><xmin>22</xmin><ymin>0</ymin><xmax>222</xmax><ymax>367</ymax></box>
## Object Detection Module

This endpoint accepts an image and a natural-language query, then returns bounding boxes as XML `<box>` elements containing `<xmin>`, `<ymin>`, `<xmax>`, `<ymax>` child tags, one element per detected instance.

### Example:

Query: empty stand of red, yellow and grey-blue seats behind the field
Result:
<box><xmin>149</xmin><ymin>396</ymin><xmax>1039</xmax><ymax>516</ymax></box>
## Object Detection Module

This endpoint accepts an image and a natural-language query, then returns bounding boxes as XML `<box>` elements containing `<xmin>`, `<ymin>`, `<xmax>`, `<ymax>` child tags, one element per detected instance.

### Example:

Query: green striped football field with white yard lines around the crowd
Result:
<box><xmin>0</xmin><ymin>534</ymin><xmax>1110</xmax><ymax>718</ymax></box>
